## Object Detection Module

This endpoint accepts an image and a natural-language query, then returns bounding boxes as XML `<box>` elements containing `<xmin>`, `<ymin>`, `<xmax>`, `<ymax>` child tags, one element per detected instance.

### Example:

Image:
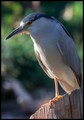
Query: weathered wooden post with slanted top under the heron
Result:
<box><xmin>30</xmin><ymin>88</ymin><xmax>83</xmax><ymax>119</ymax></box>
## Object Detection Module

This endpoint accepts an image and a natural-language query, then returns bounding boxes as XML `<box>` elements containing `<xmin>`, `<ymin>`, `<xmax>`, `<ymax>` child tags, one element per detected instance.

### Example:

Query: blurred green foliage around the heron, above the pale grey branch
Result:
<box><xmin>1</xmin><ymin>1</ymin><xmax>83</xmax><ymax>99</ymax></box>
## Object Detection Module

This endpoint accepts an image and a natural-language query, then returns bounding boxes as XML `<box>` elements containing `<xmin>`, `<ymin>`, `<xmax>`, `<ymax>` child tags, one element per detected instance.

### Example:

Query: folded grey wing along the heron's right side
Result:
<box><xmin>57</xmin><ymin>22</ymin><xmax>82</xmax><ymax>86</ymax></box>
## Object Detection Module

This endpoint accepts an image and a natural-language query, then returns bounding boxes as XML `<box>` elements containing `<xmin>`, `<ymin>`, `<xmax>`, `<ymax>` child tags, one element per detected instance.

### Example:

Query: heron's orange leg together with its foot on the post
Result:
<box><xmin>42</xmin><ymin>77</ymin><xmax>62</xmax><ymax>106</ymax></box>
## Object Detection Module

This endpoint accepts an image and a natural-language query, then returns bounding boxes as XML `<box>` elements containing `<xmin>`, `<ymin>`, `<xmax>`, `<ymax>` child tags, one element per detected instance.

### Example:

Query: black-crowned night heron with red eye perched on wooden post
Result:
<box><xmin>6</xmin><ymin>12</ymin><xmax>82</xmax><ymax>105</ymax></box>
